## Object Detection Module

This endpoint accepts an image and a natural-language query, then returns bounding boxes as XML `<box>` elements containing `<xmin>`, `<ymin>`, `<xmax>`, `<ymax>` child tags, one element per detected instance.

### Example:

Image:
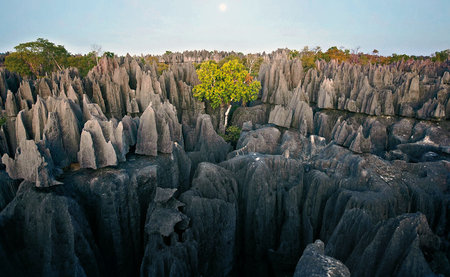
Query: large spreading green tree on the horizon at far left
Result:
<box><xmin>5</xmin><ymin>38</ymin><xmax>70</xmax><ymax>76</ymax></box>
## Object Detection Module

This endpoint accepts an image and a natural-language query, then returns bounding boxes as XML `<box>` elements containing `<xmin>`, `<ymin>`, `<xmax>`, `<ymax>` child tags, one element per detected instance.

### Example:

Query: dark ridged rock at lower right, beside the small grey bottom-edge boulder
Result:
<box><xmin>327</xmin><ymin>211</ymin><xmax>439</xmax><ymax>276</ymax></box>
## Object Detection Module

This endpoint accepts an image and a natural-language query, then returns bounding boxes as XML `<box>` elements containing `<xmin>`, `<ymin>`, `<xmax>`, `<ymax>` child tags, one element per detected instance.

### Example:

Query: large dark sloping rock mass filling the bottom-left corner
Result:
<box><xmin>0</xmin><ymin>182</ymin><xmax>105</xmax><ymax>276</ymax></box>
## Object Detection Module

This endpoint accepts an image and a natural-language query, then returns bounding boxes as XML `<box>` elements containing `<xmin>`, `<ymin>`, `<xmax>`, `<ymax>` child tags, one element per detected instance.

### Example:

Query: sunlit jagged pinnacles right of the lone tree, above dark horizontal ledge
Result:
<box><xmin>259</xmin><ymin>55</ymin><xmax>449</xmax><ymax>120</ymax></box>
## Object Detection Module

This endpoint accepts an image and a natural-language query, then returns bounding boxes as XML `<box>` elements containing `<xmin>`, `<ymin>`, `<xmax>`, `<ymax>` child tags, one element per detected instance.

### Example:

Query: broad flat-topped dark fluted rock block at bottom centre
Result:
<box><xmin>220</xmin><ymin>153</ymin><xmax>303</xmax><ymax>275</ymax></box>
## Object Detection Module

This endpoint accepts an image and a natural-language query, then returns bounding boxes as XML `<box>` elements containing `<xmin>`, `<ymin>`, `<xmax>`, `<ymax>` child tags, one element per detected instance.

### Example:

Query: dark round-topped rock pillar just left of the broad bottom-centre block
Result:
<box><xmin>180</xmin><ymin>163</ymin><xmax>239</xmax><ymax>276</ymax></box>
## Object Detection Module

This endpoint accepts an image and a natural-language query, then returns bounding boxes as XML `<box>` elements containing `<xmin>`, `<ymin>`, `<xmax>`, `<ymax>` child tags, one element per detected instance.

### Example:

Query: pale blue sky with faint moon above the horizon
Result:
<box><xmin>0</xmin><ymin>0</ymin><xmax>450</xmax><ymax>55</ymax></box>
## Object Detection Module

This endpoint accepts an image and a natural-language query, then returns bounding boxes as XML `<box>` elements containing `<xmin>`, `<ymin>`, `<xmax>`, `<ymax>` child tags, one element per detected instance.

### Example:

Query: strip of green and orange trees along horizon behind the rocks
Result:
<box><xmin>0</xmin><ymin>38</ymin><xmax>450</xmax><ymax>78</ymax></box>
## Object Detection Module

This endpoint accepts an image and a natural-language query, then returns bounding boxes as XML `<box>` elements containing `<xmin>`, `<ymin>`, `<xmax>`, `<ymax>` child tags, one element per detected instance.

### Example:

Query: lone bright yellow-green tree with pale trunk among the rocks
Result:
<box><xmin>193</xmin><ymin>59</ymin><xmax>261</xmax><ymax>133</ymax></box>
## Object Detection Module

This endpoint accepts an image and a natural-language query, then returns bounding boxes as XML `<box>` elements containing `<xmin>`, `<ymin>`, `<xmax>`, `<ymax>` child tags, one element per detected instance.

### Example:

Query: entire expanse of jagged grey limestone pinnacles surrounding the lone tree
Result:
<box><xmin>0</xmin><ymin>51</ymin><xmax>450</xmax><ymax>276</ymax></box>
